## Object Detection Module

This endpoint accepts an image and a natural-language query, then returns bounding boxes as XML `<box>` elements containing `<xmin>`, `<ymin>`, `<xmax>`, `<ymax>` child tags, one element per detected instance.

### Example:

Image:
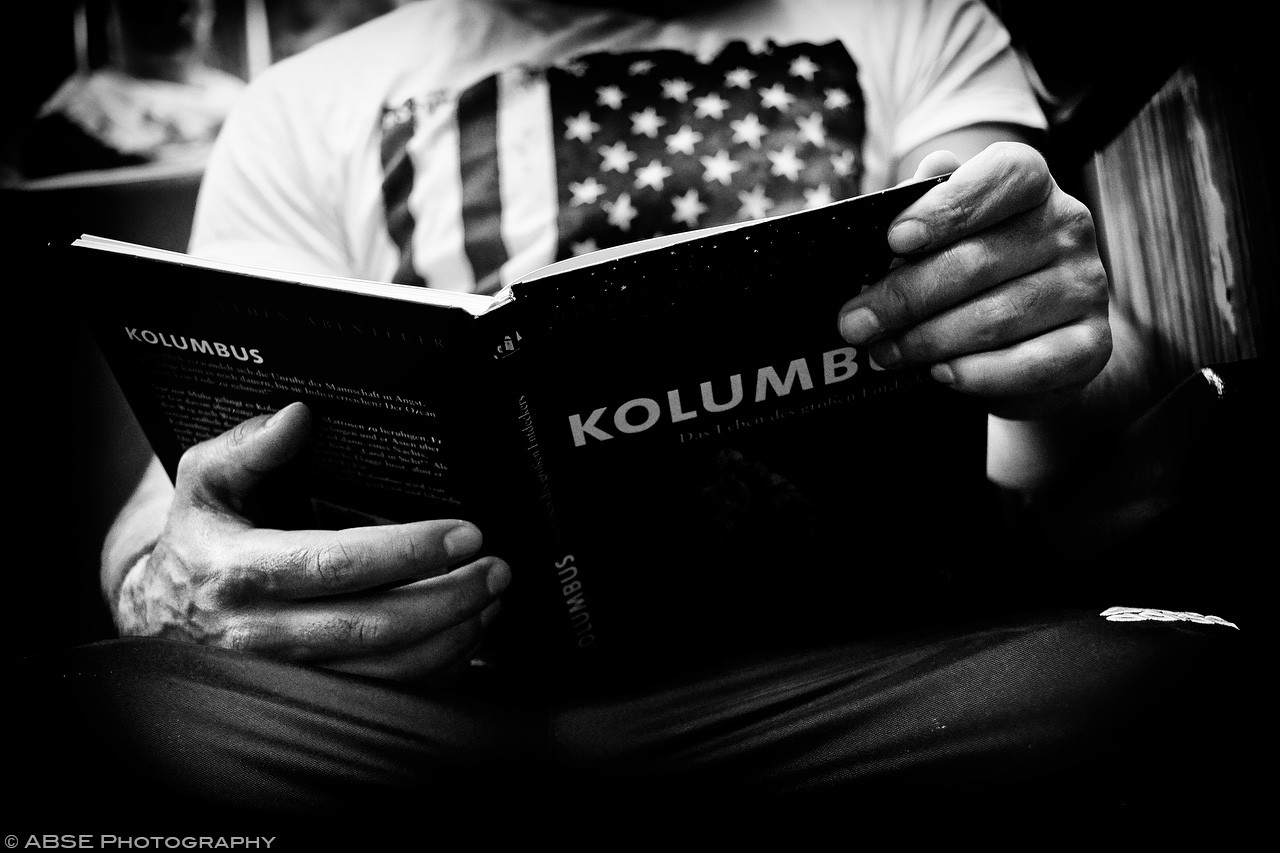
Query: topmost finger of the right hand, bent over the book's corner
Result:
<box><xmin>888</xmin><ymin>142</ymin><xmax>1056</xmax><ymax>255</ymax></box>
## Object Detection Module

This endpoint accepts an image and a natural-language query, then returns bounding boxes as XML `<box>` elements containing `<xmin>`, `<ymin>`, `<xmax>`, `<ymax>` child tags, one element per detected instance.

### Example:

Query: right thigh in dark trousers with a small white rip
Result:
<box><xmin>553</xmin><ymin>608</ymin><xmax>1256</xmax><ymax>816</ymax></box>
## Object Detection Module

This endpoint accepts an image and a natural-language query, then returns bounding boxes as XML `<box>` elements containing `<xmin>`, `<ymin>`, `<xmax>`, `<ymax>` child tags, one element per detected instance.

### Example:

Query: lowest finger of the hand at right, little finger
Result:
<box><xmin>931</xmin><ymin>316</ymin><xmax>1111</xmax><ymax>404</ymax></box>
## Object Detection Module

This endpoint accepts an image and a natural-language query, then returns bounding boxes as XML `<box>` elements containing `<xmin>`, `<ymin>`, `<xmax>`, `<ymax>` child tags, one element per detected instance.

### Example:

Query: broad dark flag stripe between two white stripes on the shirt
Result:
<box><xmin>458</xmin><ymin>77</ymin><xmax>507</xmax><ymax>293</ymax></box>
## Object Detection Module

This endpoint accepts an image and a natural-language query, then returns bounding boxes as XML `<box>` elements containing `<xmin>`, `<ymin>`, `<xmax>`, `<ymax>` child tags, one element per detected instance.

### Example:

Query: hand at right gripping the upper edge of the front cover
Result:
<box><xmin>840</xmin><ymin>142</ymin><xmax>1111</xmax><ymax>419</ymax></box>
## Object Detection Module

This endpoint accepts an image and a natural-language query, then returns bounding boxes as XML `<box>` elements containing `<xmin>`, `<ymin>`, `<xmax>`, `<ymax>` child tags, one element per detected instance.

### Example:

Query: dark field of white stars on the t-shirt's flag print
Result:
<box><xmin>545</xmin><ymin>42</ymin><xmax>865</xmax><ymax>257</ymax></box>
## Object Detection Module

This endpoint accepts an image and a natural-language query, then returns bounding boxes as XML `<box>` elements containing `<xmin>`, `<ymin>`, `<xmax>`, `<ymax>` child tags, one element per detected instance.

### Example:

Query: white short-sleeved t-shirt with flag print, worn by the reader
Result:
<box><xmin>191</xmin><ymin>0</ymin><xmax>1044</xmax><ymax>292</ymax></box>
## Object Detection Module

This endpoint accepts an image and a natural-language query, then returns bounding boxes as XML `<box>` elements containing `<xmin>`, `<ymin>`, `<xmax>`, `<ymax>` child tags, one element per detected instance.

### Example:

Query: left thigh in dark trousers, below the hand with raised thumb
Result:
<box><xmin>9</xmin><ymin>639</ymin><xmax>545</xmax><ymax>826</ymax></box>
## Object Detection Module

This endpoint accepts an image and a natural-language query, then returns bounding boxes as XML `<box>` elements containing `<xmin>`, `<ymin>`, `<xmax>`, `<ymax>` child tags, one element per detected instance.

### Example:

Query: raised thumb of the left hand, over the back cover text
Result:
<box><xmin>174</xmin><ymin>402</ymin><xmax>311</xmax><ymax>512</ymax></box>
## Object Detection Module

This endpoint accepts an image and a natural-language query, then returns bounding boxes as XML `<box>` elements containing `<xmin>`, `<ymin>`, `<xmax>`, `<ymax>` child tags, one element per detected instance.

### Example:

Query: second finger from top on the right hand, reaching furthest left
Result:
<box><xmin>840</xmin><ymin>196</ymin><xmax>1101</xmax><ymax>346</ymax></box>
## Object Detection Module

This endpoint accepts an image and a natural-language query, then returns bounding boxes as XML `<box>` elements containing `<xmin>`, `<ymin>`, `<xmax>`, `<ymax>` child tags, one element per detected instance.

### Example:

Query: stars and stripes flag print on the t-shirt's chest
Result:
<box><xmin>381</xmin><ymin>41</ymin><xmax>865</xmax><ymax>291</ymax></box>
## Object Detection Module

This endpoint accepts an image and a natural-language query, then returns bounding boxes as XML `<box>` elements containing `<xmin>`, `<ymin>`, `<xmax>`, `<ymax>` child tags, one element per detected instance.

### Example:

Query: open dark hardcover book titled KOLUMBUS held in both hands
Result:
<box><xmin>58</xmin><ymin>178</ymin><xmax>986</xmax><ymax>670</ymax></box>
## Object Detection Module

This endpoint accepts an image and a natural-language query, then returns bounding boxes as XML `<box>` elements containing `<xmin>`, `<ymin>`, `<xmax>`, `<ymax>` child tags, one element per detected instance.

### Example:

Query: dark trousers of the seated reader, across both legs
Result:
<box><xmin>9</xmin><ymin>607</ymin><xmax>1254</xmax><ymax>835</ymax></box>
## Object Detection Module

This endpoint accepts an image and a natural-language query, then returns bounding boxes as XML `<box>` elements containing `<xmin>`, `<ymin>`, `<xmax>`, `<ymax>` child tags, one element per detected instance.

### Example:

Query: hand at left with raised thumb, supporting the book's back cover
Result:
<box><xmin>116</xmin><ymin>403</ymin><xmax>511</xmax><ymax>679</ymax></box>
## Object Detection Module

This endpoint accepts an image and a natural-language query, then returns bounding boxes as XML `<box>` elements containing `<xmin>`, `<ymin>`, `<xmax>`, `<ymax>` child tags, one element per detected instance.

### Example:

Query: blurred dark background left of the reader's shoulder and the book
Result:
<box><xmin>0</xmin><ymin>0</ymin><xmax>409</xmax><ymax>656</ymax></box>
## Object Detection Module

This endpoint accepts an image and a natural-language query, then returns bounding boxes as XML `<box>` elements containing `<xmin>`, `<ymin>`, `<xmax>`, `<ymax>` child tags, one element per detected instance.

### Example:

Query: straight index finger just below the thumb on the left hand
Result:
<box><xmin>220</xmin><ymin>519</ymin><xmax>484</xmax><ymax>599</ymax></box>
